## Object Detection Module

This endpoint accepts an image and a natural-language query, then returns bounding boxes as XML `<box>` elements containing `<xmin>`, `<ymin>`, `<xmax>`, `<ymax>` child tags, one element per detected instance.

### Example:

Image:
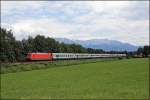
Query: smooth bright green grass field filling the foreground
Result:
<box><xmin>1</xmin><ymin>58</ymin><xmax>149</xmax><ymax>99</ymax></box>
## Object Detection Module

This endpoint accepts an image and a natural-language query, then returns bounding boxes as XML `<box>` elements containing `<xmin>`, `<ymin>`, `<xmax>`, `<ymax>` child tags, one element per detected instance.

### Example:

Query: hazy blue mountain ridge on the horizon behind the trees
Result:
<box><xmin>55</xmin><ymin>38</ymin><xmax>139</xmax><ymax>51</ymax></box>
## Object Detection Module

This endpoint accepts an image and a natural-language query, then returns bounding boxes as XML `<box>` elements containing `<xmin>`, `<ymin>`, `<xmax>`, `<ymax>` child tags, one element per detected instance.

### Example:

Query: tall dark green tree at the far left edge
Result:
<box><xmin>0</xmin><ymin>28</ymin><xmax>16</xmax><ymax>62</ymax></box>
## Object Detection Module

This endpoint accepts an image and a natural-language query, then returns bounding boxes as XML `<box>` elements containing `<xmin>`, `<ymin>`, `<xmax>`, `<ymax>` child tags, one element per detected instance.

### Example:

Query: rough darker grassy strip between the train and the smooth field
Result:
<box><xmin>0</xmin><ymin>58</ymin><xmax>118</xmax><ymax>74</ymax></box>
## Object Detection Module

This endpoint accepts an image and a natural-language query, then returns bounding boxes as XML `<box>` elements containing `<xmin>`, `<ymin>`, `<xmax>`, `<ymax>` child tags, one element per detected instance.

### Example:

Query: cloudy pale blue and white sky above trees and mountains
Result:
<box><xmin>1</xmin><ymin>1</ymin><xmax>149</xmax><ymax>45</ymax></box>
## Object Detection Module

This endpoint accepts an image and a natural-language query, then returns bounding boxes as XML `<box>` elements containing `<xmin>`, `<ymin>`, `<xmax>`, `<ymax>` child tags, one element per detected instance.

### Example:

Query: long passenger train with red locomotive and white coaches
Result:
<box><xmin>26</xmin><ymin>53</ymin><xmax>126</xmax><ymax>61</ymax></box>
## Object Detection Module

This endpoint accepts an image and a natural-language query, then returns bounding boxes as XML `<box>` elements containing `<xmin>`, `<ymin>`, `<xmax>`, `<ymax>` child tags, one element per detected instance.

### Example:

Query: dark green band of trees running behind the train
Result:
<box><xmin>0</xmin><ymin>27</ymin><xmax>149</xmax><ymax>62</ymax></box>
